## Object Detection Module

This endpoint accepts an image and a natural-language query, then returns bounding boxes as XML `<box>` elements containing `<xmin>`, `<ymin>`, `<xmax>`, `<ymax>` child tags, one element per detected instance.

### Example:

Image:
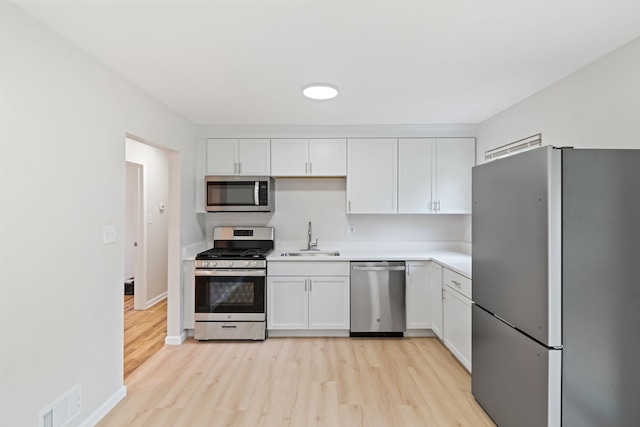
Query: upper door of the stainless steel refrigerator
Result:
<box><xmin>472</xmin><ymin>147</ymin><xmax>562</xmax><ymax>348</ymax></box>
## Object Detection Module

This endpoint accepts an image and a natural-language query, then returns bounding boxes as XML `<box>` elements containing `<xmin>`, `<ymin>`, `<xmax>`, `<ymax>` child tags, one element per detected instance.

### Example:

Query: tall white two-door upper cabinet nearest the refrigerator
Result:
<box><xmin>398</xmin><ymin>138</ymin><xmax>475</xmax><ymax>213</ymax></box>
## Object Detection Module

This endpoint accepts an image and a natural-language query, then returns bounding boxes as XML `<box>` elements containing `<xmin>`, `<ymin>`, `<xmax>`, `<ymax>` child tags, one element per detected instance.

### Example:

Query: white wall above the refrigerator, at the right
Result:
<box><xmin>476</xmin><ymin>39</ymin><xmax>640</xmax><ymax>160</ymax></box>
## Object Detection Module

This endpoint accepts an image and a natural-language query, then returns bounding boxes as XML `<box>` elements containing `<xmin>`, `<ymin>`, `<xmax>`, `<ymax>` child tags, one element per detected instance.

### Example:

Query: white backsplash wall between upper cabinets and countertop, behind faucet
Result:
<box><xmin>206</xmin><ymin>178</ymin><xmax>470</xmax><ymax>249</ymax></box>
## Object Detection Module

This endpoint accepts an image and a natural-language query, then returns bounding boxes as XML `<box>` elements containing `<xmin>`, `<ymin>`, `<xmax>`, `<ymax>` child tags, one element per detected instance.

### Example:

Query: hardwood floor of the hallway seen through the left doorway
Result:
<box><xmin>124</xmin><ymin>295</ymin><xmax>167</xmax><ymax>381</ymax></box>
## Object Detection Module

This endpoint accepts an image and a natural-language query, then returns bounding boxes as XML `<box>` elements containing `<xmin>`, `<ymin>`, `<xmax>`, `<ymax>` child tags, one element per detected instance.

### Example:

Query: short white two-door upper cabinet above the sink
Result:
<box><xmin>271</xmin><ymin>139</ymin><xmax>347</xmax><ymax>177</ymax></box>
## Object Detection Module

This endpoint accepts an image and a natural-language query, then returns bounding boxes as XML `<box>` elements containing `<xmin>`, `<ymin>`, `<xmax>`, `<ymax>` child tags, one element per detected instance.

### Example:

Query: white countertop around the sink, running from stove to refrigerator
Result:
<box><xmin>267</xmin><ymin>249</ymin><xmax>471</xmax><ymax>279</ymax></box>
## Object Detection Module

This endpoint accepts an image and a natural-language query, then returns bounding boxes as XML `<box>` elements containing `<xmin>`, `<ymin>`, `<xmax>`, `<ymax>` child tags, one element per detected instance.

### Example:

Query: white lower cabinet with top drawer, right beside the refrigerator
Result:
<box><xmin>443</xmin><ymin>268</ymin><xmax>472</xmax><ymax>372</ymax></box>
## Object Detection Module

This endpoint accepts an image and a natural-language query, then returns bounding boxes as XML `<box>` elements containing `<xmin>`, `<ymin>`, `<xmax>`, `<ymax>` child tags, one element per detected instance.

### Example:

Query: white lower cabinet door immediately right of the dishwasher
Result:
<box><xmin>406</xmin><ymin>262</ymin><xmax>431</xmax><ymax>329</ymax></box>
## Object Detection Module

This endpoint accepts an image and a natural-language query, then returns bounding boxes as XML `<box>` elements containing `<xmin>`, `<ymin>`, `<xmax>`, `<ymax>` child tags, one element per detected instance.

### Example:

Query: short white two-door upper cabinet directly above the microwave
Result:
<box><xmin>207</xmin><ymin>139</ymin><xmax>271</xmax><ymax>176</ymax></box>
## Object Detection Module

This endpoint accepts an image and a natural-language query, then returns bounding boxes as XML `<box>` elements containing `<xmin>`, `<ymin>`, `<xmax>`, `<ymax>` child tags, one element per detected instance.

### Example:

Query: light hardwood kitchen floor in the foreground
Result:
<box><xmin>99</xmin><ymin>338</ymin><xmax>494</xmax><ymax>427</ymax></box>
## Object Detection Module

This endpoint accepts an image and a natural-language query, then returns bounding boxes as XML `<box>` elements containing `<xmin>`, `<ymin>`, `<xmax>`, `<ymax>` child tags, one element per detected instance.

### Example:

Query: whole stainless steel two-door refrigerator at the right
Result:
<box><xmin>472</xmin><ymin>146</ymin><xmax>640</xmax><ymax>427</ymax></box>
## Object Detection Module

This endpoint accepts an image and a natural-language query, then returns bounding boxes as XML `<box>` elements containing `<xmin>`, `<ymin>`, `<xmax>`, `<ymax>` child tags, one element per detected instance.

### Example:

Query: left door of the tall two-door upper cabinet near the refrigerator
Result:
<box><xmin>398</xmin><ymin>138</ymin><xmax>436</xmax><ymax>213</ymax></box>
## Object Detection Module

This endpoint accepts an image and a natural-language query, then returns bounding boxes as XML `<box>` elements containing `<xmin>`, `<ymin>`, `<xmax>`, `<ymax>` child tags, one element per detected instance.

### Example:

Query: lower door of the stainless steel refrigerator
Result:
<box><xmin>471</xmin><ymin>305</ymin><xmax>562</xmax><ymax>427</ymax></box>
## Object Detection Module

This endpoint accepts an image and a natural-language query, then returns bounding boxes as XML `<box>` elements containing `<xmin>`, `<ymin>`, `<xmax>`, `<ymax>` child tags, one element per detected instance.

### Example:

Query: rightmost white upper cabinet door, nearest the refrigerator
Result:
<box><xmin>434</xmin><ymin>138</ymin><xmax>476</xmax><ymax>213</ymax></box>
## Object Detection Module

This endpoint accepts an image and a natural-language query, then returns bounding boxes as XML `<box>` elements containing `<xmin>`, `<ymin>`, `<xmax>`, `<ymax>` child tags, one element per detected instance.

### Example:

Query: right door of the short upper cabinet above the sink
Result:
<box><xmin>309</xmin><ymin>139</ymin><xmax>347</xmax><ymax>176</ymax></box>
